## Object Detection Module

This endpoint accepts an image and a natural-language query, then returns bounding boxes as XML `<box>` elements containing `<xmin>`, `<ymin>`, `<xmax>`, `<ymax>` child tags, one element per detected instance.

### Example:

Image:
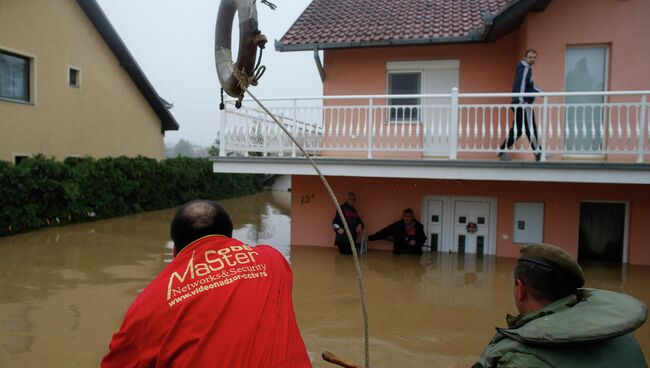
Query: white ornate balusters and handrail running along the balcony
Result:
<box><xmin>220</xmin><ymin>89</ymin><xmax>650</xmax><ymax>162</ymax></box>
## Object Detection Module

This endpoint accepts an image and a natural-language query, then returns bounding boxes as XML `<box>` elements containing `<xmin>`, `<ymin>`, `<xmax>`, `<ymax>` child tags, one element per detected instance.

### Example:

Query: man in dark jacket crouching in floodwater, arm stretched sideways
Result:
<box><xmin>368</xmin><ymin>208</ymin><xmax>427</xmax><ymax>254</ymax></box>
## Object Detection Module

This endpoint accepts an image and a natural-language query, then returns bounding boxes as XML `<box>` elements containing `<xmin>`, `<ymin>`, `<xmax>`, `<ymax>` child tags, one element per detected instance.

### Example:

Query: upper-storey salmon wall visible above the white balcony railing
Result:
<box><xmin>323</xmin><ymin>0</ymin><xmax>650</xmax><ymax>95</ymax></box>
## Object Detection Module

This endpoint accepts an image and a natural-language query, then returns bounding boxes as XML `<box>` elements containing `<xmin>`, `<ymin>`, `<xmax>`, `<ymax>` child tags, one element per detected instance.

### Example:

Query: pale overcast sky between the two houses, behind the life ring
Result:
<box><xmin>98</xmin><ymin>0</ymin><xmax>322</xmax><ymax>146</ymax></box>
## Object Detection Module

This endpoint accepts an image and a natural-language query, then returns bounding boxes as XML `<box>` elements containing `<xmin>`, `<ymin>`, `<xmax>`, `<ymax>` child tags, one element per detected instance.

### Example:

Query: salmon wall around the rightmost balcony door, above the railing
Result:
<box><xmin>517</xmin><ymin>0</ymin><xmax>650</xmax><ymax>95</ymax></box>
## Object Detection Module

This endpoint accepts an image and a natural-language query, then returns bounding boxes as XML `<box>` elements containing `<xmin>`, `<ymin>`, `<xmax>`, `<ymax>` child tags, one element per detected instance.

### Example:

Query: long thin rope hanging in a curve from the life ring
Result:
<box><xmin>235</xmin><ymin>85</ymin><xmax>370</xmax><ymax>368</ymax></box>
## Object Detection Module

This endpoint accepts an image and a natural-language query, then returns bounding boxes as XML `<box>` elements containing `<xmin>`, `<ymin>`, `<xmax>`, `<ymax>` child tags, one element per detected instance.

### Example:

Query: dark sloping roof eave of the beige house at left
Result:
<box><xmin>77</xmin><ymin>0</ymin><xmax>179</xmax><ymax>132</ymax></box>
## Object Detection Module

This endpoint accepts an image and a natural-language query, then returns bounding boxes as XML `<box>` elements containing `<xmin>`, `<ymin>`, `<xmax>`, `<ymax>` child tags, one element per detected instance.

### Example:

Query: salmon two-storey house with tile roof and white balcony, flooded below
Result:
<box><xmin>213</xmin><ymin>0</ymin><xmax>650</xmax><ymax>265</ymax></box>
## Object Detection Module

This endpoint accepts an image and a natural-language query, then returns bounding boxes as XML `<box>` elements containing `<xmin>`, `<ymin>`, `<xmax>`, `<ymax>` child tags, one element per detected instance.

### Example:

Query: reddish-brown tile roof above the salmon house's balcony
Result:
<box><xmin>278</xmin><ymin>0</ymin><xmax>518</xmax><ymax>48</ymax></box>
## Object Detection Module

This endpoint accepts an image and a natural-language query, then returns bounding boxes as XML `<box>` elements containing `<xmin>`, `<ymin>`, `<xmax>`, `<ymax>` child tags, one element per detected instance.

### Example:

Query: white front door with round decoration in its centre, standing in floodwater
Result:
<box><xmin>453</xmin><ymin>201</ymin><xmax>490</xmax><ymax>255</ymax></box>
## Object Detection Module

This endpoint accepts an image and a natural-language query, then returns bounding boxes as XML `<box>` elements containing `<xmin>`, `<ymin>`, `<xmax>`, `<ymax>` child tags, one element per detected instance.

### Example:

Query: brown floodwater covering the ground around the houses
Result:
<box><xmin>0</xmin><ymin>192</ymin><xmax>650</xmax><ymax>368</ymax></box>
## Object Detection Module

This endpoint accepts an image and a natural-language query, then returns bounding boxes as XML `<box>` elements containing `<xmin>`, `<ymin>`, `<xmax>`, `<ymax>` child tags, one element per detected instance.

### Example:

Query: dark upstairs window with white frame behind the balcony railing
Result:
<box><xmin>388</xmin><ymin>72</ymin><xmax>422</xmax><ymax>121</ymax></box>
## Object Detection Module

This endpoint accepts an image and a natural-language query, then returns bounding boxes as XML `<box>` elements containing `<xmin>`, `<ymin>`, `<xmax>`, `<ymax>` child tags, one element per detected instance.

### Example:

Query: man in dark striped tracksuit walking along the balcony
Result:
<box><xmin>499</xmin><ymin>49</ymin><xmax>542</xmax><ymax>161</ymax></box>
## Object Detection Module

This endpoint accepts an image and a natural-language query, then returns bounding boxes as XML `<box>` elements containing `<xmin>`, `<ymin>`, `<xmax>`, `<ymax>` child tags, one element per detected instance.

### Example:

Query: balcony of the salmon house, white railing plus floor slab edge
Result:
<box><xmin>212</xmin><ymin>90</ymin><xmax>650</xmax><ymax>184</ymax></box>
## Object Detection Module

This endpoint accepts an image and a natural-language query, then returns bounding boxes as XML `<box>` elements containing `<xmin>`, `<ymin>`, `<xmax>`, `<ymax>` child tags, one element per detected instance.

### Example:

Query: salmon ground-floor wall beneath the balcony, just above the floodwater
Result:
<box><xmin>291</xmin><ymin>176</ymin><xmax>650</xmax><ymax>265</ymax></box>
